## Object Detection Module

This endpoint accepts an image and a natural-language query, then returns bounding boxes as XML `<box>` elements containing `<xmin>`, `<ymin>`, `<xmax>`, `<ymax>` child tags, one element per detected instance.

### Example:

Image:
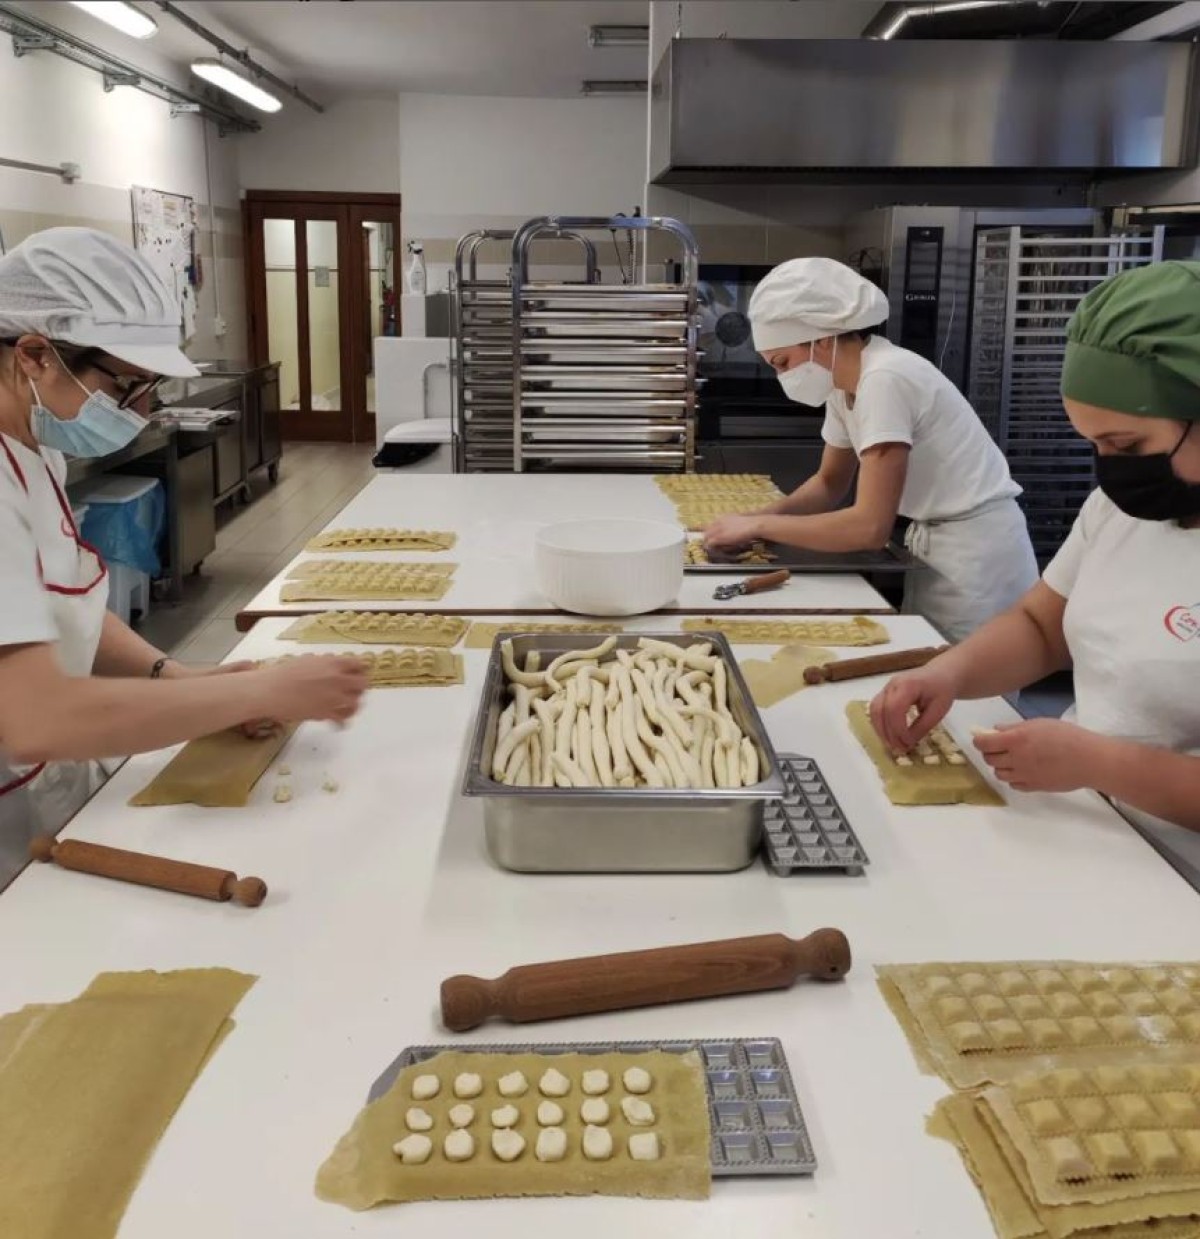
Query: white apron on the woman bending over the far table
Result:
<box><xmin>902</xmin><ymin>499</ymin><xmax>1038</xmax><ymax>641</ymax></box>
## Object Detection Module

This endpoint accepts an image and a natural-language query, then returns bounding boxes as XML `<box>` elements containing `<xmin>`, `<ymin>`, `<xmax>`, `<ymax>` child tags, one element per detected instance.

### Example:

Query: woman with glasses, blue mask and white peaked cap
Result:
<box><xmin>0</xmin><ymin>228</ymin><xmax>367</xmax><ymax>886</ymax></box>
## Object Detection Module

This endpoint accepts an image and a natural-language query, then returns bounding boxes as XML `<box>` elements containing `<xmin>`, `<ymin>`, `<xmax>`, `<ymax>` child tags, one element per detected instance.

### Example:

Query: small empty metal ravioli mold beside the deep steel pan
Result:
<box><xmin>763</xmin><ymin>753</ymin><xmax>868</xmax><ymax>877</ymax></box>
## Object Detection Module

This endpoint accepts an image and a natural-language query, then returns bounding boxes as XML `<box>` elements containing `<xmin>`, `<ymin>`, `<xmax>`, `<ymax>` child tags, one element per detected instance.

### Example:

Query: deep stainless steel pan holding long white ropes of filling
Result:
<box><xmin>463</xmin><ymin>634</ymin><xmax>784</xmax><ymax>873</ymax></box>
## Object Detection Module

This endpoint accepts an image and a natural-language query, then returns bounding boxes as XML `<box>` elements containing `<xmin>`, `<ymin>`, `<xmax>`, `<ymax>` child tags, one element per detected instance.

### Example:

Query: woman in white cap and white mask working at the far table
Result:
<box><xmin>705</xmin><ymin>258</ymin><xmax>1038</xmax><ymax>641</ymax></box>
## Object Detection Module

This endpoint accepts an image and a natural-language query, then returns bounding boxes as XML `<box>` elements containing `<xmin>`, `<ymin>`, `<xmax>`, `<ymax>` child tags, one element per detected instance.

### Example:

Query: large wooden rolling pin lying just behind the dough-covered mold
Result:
<box><xmin>442</xmin><ymin>929</ymin><xmax>850</xmax><ymax>1032</ymax></box>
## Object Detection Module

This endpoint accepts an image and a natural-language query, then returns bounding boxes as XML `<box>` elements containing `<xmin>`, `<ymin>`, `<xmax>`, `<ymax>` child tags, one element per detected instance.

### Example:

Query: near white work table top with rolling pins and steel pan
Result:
<box><xmin>0</xmin><ymin>617</ymin><xmax>1200</xmax><ymax>1239</ymax></box>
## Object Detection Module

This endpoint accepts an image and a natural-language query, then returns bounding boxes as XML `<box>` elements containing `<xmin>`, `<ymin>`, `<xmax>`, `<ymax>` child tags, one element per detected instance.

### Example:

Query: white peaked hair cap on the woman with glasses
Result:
<box><xmin>0</xmin><ymin>228</ymin><xmax>199</xmax><ymax>378</ymax></box>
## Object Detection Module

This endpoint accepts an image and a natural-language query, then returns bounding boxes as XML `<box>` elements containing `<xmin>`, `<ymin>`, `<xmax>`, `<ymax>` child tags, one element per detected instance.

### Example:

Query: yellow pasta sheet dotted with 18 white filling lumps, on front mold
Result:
<box><xmin>316</xmin><ymin>1051</ymin><xmax>712</xmax><ymax>1209</ymax></box>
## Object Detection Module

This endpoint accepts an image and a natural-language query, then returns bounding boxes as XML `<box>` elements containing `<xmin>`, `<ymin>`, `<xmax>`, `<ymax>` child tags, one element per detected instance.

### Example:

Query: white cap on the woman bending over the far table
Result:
<box><xmin>750</xmin><ymin>258</ymin><xmax>888</xmax><ymax>352</ymax></box>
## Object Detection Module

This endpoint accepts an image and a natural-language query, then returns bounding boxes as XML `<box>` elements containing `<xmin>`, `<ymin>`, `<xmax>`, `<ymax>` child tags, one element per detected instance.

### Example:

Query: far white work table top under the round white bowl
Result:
<box><xmin>238</xmin><ymin>473</ymin><xmax>892</xmax><ymax>632</ymax></box>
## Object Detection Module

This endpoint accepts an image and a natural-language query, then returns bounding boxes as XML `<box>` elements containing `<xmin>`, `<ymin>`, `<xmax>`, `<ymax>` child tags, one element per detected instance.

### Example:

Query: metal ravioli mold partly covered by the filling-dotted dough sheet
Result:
<box><xmin>367</xmin><ymin>1037</ymin><xmax>816</xmax><ymax>1178</ymax></box>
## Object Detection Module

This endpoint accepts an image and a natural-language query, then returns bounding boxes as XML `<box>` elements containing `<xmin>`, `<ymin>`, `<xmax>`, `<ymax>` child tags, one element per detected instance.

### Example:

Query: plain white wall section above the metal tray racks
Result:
<box><xmin>400</xmin><ymin>94</ymin><xmax>645</xmax><ymax>291</ymax></box>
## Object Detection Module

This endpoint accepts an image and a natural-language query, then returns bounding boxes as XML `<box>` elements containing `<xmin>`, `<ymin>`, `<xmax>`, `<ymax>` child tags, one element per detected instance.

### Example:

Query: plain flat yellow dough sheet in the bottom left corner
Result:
<box><xmin>0</xmin><ymin>968</ymin><xmax>255</xmax><ymax>1239</ymax></box>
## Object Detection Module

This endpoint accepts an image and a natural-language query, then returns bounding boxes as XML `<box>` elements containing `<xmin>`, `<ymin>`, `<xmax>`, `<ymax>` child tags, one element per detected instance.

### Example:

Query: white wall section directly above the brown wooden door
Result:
<box><xmin>237</xmin><ymin>95</ymin><xmax>400</xmax><ymax>193</ymax></box>
